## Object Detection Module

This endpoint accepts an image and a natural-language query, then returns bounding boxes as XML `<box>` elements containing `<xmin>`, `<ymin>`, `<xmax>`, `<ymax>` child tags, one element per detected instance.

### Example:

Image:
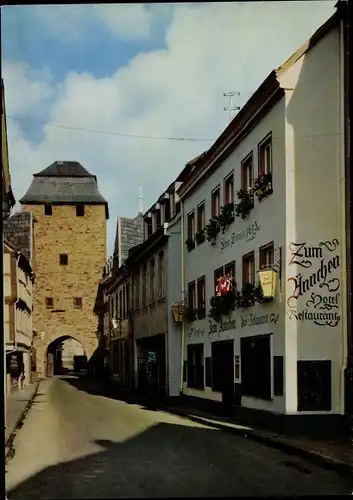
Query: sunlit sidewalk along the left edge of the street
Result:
<box><xmin>5</xmin><ymin>382</ymin><xmax>39</xmax><ymax>448</ymax></box>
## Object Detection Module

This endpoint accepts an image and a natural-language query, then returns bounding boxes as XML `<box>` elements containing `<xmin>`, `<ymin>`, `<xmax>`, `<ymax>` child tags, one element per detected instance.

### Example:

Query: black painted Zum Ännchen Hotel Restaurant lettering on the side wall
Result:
<box><xmin>287</xmin><ymin>238</ymin><xmax>341</xmax><ymax>327</ymax></box>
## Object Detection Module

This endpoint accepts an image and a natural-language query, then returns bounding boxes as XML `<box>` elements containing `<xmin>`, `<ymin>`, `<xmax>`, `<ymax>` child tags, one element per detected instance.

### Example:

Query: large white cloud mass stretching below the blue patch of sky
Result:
<box><xmin>5</xmin><ymin>2</ymin><xmax>335</xmax><ymax>251</ymax></box>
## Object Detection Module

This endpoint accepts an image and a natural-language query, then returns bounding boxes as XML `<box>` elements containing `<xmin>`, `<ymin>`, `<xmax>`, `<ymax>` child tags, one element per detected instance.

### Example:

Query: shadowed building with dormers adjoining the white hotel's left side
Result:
<box><xmin>126</xmin><ymin>162</ymin><xmax>194</xmax><ymax>397</ymax></box>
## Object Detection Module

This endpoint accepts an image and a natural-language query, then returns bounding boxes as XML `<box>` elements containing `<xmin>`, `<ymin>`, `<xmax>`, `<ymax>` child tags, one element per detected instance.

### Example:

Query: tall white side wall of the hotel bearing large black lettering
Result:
<box><xmin>280</xmin><ymin>23</ymin><xmax>346</xmax><ymax>413</ymax></box>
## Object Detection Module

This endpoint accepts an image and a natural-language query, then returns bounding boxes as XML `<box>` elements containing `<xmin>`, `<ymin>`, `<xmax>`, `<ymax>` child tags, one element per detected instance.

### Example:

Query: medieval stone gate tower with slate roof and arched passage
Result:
<box><xmin>20</xmin><ymin>161</ymin><xmax>109</xmax><ymax>376</ymax></box>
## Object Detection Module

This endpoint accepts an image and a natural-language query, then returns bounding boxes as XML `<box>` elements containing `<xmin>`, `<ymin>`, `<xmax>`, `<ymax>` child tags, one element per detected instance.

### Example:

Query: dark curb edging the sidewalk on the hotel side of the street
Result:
<box><xmin>164</xmin><ymin>407</ymin><xmax>353</xmax><ymax>476</ymax></box>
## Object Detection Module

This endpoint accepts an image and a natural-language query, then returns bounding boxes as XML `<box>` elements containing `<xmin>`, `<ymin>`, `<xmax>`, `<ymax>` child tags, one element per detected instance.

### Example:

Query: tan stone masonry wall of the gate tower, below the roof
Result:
<box><xmin>23</xmin><ymin>205</ymin><xmax>106</xmax><ymax>375</ymax></box>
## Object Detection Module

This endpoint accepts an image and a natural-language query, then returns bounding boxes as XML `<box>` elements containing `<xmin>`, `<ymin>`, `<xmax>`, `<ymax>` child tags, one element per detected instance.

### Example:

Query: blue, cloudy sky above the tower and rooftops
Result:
<box><xmin>1</xmin><ymin>0</ymin><xmax>336</xmax><ymax>255</ymax></box>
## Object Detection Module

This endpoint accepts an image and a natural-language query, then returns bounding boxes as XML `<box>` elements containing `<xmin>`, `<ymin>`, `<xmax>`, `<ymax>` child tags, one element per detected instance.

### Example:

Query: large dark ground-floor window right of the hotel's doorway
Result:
<box><xmin>240</xmin><ymin>335</ymin><xmax>271</xmax><ymax>399</ymax></box>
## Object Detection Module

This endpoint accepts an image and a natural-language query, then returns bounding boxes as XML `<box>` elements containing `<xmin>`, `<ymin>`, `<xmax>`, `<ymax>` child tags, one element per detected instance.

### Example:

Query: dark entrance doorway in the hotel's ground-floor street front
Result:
<box><xmin>211</xmin><ymin>340</ymin><xmax>234</xmax><ymax>416</ymax></box>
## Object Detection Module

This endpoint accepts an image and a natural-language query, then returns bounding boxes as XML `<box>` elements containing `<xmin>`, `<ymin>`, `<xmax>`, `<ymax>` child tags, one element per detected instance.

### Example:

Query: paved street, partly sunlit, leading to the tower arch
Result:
<box><xmin>6</xmin><ymin>377</ymin><xmax>351</xmax><ymax>500</ymax></box>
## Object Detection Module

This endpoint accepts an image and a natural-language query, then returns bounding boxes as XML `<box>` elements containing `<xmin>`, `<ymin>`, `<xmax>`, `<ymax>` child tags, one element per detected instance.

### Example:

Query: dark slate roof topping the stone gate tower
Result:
<box><xmin>20</xmin><ymin>161</ymin><xmax>109</xmax><ymax>219</ymax></box>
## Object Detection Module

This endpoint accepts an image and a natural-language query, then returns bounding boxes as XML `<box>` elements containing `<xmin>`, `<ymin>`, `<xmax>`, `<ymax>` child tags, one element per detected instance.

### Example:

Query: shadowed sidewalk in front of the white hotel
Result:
<box><xmin>164</xmin><ymin>406</ymin><xmax>353</xmax><ymax>474</ymax></box>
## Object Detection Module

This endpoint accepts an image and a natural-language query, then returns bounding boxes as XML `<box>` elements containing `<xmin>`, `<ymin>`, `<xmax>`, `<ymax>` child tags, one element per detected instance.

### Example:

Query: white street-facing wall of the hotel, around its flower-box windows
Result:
<box><xmin>183</xmin><ymin>99</ymin><xmax>285</xmax><ymax>411</ymax></box>
